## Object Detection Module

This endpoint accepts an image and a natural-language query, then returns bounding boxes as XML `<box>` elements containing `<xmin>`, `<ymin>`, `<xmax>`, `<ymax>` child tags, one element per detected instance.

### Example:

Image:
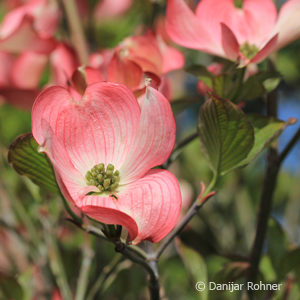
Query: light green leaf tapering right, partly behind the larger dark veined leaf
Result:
<box><xmin>239</xmin><ymin>115</ymin><xmax>289</xmax><ymax>166</ymax></box>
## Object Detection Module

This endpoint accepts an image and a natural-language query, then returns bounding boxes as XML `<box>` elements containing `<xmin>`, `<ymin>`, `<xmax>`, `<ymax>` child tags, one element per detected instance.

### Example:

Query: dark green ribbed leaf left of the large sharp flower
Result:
<box><xmin>8</xmin><ymin>133</ymin><xmax>59</xmax><ymax>193</ymax></box>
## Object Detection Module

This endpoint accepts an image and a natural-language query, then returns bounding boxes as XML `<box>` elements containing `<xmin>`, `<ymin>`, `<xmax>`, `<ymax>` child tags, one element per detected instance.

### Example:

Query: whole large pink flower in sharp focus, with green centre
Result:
<box><xmin>32</xmin><ymin>82</ymin><xmax>181</xmax><ymax>244</ymax></box>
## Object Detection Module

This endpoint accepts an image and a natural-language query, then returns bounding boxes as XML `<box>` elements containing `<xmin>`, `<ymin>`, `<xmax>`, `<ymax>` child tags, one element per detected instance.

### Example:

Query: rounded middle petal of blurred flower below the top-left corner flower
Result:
<box><xmin>11</xmin><ymin>52</ymin><xmax>48</xmax><ymax>89</ymax></box>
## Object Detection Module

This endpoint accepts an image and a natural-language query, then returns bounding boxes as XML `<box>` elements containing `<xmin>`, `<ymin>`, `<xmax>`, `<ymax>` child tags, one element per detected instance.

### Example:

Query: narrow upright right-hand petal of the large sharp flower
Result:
<box><xmin>120</xmin><ymin>87</ymin><xmax>176</xmax><ymax>183</ymax></box>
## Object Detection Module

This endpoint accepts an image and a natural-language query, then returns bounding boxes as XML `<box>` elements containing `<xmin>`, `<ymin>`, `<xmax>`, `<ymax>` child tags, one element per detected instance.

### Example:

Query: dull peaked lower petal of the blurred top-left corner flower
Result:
<box><xmin>0</xmin><ymin>16</ymin><xmax>56</xmax><ymax>54</ymax></box>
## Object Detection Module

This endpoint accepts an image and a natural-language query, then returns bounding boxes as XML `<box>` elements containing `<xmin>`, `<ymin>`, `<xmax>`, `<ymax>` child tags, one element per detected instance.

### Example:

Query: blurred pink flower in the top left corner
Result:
<box><xmin>0</xmin><ymin>0</ymin><xmax>60</xmax><ymax>53</ymax></box>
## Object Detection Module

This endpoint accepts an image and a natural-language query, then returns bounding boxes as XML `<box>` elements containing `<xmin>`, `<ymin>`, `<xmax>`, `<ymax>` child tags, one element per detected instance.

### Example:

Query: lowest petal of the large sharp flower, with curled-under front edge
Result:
<box><xmin>80</xmin><ymin>169</ymin><xmax>181</xmax><ymax>244</ymax></box>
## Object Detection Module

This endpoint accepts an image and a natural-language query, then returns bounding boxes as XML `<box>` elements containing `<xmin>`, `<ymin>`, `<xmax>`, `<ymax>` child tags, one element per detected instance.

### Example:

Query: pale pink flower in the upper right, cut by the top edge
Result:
<box><xmin>167</xmin><ymin>0</ymin><xmax>300</xmax><ymax>65</ymax></box>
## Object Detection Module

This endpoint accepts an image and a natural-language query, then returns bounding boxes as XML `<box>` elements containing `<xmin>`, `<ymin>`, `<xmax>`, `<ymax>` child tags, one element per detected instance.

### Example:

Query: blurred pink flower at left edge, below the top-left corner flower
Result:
<box><xmin>0</xmin><ymin>43</ymin><xmax>79</xmax><ymax>109</ymax></box>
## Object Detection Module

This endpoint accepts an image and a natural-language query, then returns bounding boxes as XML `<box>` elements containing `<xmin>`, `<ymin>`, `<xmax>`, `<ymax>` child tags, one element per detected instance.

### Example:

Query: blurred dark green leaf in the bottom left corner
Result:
<box><xmin>0</xmin><ymin>274</ymin><xmax>24</xmax><ymax>300</ymax></box>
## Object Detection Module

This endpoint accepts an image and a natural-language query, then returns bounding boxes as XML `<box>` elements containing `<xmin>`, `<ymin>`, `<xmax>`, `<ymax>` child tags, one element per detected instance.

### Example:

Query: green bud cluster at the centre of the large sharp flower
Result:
<box><xmin>85</xmin><ymin>163</ymin><xmax>120</xmax><ymax>193</ymax></box>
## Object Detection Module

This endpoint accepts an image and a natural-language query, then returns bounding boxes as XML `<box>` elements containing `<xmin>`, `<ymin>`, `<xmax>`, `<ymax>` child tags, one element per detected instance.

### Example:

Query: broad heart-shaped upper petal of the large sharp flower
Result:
<box><xmin>32</xmin><ymin>82</ymin><xmax>140</xmax><ymax>177</ymax></box>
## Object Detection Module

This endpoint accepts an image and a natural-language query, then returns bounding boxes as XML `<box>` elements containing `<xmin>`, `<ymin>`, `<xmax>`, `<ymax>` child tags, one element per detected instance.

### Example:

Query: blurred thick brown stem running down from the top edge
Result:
<box><xmin>62</xmin><ymin>0</ymin><xmax>89</xmax><ymax>65</ymax></box>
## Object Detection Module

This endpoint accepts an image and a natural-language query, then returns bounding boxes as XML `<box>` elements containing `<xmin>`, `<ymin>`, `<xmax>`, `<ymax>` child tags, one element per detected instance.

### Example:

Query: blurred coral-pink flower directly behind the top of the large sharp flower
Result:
<box><xmin>107</xmin><ymin>31</ymin><xmax>184</xmax><ymax>97</ymax></box>
